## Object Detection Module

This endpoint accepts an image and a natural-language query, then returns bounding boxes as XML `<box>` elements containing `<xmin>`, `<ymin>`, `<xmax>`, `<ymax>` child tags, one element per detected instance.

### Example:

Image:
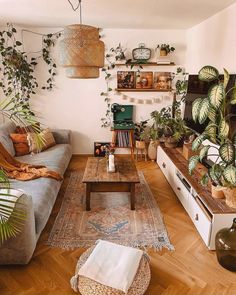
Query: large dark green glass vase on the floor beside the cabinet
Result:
<box><xmin>215</xmin><ymin>218</ymin><xmax>236</xmax><ymax>271</ymax></box>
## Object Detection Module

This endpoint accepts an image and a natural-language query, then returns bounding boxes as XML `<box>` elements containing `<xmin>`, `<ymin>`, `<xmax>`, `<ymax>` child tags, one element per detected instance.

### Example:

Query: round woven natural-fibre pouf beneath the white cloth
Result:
<box><xmin>75</xmin><ymin>246</ymin><xmax>151</xmax><ymax>295</ymax></box>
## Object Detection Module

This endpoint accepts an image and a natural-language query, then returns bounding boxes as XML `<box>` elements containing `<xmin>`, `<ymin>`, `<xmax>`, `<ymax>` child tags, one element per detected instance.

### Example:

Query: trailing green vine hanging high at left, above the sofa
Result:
<box><xmin>0</xmin><ymin>24</ymin><xmax>61</xmax><ymax>108</ymax></box>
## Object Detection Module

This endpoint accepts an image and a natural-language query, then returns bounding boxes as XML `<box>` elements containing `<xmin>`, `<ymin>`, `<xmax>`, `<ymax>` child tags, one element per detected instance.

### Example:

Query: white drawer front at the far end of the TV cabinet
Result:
<box><xmin>157</xmin><ymin>146</ymin><xmax>175</xmax><ymax>185</ymax></box>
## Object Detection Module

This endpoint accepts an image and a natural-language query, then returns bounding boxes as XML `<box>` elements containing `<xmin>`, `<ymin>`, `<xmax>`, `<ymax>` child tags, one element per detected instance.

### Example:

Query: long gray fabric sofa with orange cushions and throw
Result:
<box><xmin>0</xmin><ymin>122</ymin><xmax>72</xmax><ymax>264</ymax></box>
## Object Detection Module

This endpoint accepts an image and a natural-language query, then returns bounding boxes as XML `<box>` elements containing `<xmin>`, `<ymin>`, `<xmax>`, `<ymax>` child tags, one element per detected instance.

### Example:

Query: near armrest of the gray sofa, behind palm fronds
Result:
<box><xmin>0</xmin><ymin>193</ymin><xmax>36</xmax><ymax>265</ymax></box>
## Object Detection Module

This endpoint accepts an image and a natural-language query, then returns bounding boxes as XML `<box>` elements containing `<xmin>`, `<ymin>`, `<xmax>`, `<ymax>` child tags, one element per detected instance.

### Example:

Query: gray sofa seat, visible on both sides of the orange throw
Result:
<box><xmin>12</xmin><ymin>144</ymin><xmax>71</xmax><ymax>236</ymax></box>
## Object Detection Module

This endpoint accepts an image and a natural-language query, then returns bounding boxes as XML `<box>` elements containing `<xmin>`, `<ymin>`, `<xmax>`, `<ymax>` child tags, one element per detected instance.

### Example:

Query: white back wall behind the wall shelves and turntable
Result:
<box><xmin>19</xmin><ymin>28</ymin><xmax>186</xmax><ymax>154</ymax></box>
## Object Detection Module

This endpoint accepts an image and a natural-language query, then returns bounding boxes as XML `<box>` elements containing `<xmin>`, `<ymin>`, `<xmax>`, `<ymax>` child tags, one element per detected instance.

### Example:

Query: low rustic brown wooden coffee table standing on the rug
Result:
<box><xmin>82</xmin><ymin>156</ymin><xmax>140</xmax><ymax>211</ymax></box>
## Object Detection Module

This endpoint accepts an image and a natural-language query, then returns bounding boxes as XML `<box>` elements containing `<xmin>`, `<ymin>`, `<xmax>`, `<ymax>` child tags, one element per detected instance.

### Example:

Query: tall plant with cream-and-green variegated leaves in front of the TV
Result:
<box><xmin>189</xmin><ymin>66</ymin><xmax>236</xmax><ymax>207</ymax></box>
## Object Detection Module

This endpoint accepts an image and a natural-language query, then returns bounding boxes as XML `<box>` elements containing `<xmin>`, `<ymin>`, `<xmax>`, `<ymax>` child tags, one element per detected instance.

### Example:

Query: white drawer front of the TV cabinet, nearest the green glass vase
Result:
<box><xmin>188</xmin><ymin>196</ymin><xmax>212</xmax><ymax>246</ymax></box>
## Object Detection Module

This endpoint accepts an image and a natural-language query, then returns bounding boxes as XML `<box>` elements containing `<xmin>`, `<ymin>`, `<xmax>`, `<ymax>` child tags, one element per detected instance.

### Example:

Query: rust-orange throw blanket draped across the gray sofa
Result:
<box><xmin>0</xmin><ymin>143</ymin><xmax>63</xmax><ymax>180</ymax></box>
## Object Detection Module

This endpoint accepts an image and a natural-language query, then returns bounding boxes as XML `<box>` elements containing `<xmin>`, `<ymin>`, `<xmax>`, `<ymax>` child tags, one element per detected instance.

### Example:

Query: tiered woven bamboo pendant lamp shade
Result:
<box><xmin>60</xmin><ymin>24</ymin><xmax>105</xmax><ymax>79</ymax></box>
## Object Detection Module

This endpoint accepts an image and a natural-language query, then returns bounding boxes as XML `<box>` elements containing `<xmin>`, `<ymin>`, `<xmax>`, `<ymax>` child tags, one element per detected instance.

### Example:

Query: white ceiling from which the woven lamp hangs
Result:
<box><xmin>0</xmin><ymin>0</ymin><xmax>236</xmax><ymax>29</ymax></box>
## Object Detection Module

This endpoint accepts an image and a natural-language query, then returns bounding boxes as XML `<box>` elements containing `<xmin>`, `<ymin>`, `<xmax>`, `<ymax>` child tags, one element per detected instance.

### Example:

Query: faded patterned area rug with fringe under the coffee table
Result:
<box><xmin>47</xmin><ymin>171</ymin><xmax>174</xmax><ymax>250</ymax></box>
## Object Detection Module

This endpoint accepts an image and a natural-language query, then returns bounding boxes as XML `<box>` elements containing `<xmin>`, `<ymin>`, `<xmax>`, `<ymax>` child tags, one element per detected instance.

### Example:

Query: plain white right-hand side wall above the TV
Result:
<box><xmin>186</xmin><ymin>4</ymin><xmax>236</xmax><ymax>74</ymax></box>
